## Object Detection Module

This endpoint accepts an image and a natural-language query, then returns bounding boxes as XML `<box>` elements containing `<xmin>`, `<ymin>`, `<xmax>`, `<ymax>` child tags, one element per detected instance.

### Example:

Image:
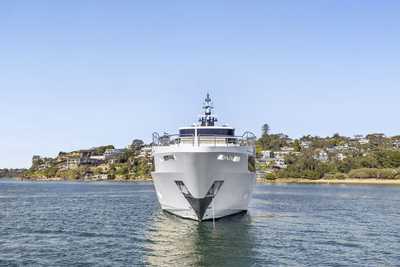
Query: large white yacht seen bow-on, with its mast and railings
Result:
<box><xmin>151</xmin><ymin>94</ymin><xmax>256</xmax><ymax>221</ymax></box>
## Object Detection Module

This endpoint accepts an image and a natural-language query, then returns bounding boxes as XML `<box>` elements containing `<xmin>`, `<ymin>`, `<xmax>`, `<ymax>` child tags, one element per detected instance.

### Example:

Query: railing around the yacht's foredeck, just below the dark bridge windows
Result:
<box><xmin>152</xmin><ymin>132</ymin><xmax>256</xmax><ymax>146</ymax></box>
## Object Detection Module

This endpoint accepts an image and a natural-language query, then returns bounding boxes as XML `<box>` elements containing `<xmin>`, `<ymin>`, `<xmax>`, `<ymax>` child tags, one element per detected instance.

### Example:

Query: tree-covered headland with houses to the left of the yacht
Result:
<box><xmin>23</xmin><ymin>142</ymin><xmax>152</xmax><ymax>180</ymax></box>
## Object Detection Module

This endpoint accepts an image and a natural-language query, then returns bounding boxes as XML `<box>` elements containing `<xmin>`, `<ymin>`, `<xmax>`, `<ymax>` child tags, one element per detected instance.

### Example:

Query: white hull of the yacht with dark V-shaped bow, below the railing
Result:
<box><xmin>152</xmin><ymin>147</ymin><xmax>255</xmax><ymax>221</ymax></box>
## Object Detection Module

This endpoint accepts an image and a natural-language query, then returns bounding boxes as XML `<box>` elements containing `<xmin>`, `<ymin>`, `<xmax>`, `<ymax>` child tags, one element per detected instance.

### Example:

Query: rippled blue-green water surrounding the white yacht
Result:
<box><xmin>0</xmin><ymin>180</ymin><xmax>400</xmax><ymax>266</ymax></box>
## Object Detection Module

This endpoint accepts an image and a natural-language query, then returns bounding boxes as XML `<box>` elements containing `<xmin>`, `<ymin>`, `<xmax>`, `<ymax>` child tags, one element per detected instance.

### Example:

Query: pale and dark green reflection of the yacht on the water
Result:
<box><xmin>144</xmin><ymin>212</ymin><xmax>255</xmax><ymax>266</ymax></box>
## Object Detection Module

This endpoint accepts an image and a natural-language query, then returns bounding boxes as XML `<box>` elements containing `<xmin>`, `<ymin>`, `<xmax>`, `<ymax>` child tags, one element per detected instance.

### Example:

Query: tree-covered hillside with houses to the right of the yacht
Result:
<box><xmin>256</xmin><ymin>124</ymin><xmax>400</xmax><ymax>179</ymax></box>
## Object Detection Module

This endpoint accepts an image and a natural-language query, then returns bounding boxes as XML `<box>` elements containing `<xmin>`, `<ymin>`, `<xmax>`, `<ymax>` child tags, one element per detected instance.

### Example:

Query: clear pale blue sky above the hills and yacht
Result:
<box><xmin>0</xmin><ymin>0</ymin><xmax>400</xmax><ymax>168</ymax></box>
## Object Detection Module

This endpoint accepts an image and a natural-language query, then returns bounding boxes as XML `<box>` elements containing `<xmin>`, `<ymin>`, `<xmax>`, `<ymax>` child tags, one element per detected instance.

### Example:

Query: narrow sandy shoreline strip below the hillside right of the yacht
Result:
<box><xmin>257</xmin><ymin>178</ymin><xmax>400</xmax><ymax>185</ymax></box>
